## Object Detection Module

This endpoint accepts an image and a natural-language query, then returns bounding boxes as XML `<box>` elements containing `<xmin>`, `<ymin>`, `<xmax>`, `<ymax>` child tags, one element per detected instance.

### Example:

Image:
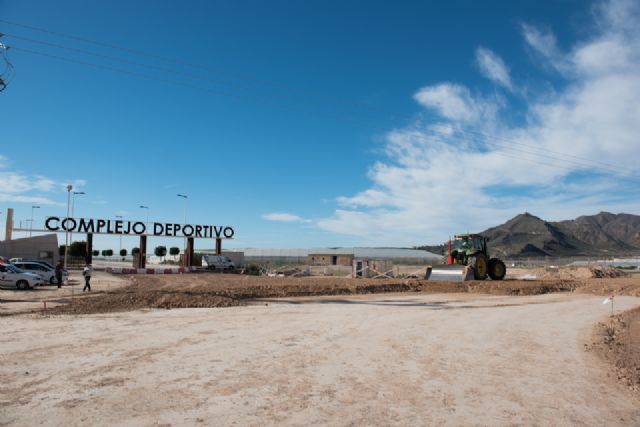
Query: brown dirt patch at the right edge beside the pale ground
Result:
<box><xmin>586</xmin><ymin>308</ymin><xmax>640</xmax><ymax>394</ymax></box>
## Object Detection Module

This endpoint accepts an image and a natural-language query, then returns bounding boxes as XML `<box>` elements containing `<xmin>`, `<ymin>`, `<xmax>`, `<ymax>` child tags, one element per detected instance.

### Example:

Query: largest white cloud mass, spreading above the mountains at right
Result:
<box><xmin>318</xmin><ymin>0</ymin><xmax>640</xmax><ymax>245</ymax></box>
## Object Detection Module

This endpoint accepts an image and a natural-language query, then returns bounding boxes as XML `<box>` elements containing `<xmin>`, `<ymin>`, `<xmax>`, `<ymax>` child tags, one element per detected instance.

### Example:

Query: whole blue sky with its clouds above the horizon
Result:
<box><xmin>0</xmin><ymin>0</ymin><xmax>640</xmax><ymax>248</ymax></box>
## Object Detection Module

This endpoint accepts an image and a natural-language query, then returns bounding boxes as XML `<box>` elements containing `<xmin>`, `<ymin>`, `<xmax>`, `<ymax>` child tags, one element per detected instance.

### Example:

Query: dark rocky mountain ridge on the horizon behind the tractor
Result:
<box><xmin>424</xmin><ymin>212</ymin><xmax>640</xmax><ymax>258</ymax></box>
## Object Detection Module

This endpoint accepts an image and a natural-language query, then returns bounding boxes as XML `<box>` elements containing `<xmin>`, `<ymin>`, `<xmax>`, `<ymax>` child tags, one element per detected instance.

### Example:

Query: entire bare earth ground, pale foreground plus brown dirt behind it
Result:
<box><xmin>0</xmin><ymin>260</ymin><xmax>640</xmax><ymax>425</ymax></box>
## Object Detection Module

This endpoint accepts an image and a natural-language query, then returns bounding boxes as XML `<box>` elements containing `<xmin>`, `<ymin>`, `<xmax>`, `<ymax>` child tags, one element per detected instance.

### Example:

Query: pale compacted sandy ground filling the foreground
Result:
<box><xmin>0</xmin><ymin>294</ymin><xmax>640</xmax><ymax>426</ymax></box>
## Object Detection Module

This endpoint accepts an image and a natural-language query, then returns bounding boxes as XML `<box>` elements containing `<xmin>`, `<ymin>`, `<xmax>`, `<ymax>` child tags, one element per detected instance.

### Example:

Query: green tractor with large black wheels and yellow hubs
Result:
<box><xmin>447</xmin><ymin>234</ymin><xmax>507</xmax><ymax>280</ymax></box>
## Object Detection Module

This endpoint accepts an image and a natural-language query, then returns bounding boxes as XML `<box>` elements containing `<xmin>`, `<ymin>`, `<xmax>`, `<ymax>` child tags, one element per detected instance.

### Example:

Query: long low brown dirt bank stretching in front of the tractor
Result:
<box><xmin>43</xmin><ymin>274</ymin><xmax>580</xmax><ymax>314</ymax></box>
